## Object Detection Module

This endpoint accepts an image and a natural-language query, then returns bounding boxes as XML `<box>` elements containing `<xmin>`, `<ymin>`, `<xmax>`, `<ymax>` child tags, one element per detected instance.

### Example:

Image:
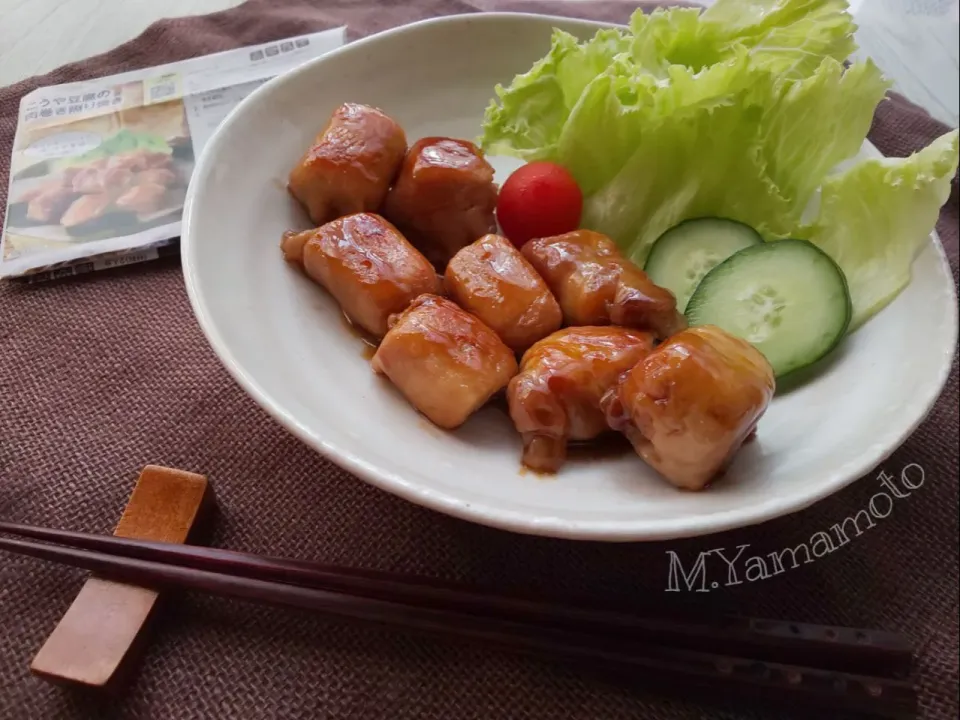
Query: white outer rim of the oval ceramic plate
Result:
<box><xmin>181</xmin><ymin>12</ymin><xmax>960</xmax><ymax>542</ymax></box>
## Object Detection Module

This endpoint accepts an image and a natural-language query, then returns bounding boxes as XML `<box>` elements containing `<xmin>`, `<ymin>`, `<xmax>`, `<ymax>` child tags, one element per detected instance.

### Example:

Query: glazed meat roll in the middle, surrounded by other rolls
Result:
<box><xmin>444</xmin><ymin>235</ymin><xmax>563</xmax><ymax>352</ymax></box>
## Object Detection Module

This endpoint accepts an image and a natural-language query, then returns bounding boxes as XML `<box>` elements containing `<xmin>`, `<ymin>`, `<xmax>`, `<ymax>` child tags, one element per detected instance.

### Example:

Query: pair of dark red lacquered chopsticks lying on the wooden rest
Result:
<box><xmin>0</xmin><ymin>522</ymin><xmax>917</xmax><ymax>719</ymax></box>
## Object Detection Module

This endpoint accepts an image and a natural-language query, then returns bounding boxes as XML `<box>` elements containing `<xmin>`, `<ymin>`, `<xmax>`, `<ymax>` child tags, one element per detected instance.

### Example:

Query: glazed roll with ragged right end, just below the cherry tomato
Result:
<box><xmin>522</xmin><ymin>230</ymin><xmax>686</xmax><ymax>339</ymax></box>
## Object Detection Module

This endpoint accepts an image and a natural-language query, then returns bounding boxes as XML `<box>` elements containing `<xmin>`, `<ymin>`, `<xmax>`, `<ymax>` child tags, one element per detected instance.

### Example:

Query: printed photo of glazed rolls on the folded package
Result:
<box><xmin>4</xmin><ymin>91</ymin><xmax>194</xmax><ymax>257</ymax></box>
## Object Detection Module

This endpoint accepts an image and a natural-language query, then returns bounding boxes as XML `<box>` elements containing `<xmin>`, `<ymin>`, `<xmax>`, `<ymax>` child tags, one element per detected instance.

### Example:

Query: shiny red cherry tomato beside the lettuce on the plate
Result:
<box><xmin>497</xmin><ymin>162</ymin><xmax>583</xmax><ymax>247</ymax></box>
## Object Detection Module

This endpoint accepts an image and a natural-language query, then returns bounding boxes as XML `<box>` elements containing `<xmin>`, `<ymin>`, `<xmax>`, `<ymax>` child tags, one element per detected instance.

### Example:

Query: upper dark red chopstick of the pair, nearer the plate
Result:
<box><xmin>0</xmin><ymin>522</ymin><xmax>912</xmax><ymax>676</ymax></box>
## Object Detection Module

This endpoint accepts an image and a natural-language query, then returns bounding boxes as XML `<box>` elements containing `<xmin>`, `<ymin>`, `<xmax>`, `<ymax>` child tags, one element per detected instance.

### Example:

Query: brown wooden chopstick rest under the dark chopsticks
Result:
<box><xmin>30</xmin><ymin>465</ymin><xmax>214</xmax><ymax>689</ymax></box>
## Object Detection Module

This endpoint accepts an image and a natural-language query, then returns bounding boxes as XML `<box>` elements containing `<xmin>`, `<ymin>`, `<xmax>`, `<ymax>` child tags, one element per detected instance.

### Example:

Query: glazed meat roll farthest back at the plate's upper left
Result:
<box><xmin>287</xmin><ymin>103</ymin><xmax>407</xmax><ymax>225</ymax></box>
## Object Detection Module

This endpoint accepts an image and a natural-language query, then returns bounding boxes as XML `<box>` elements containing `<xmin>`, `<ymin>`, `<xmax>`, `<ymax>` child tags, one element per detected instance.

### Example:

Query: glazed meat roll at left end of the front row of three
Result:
<box><xmin>372</xmin><ymin>295</ymin><xmax>517</xmax><ymax>430</ymax></box>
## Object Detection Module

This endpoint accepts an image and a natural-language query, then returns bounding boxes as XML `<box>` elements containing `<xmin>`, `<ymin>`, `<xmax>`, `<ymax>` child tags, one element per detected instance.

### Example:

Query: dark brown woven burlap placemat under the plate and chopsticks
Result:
<box><xmin>0</xmin><ymin>0</ymin><xmax>958</xmax><ymax>720</ymax></box>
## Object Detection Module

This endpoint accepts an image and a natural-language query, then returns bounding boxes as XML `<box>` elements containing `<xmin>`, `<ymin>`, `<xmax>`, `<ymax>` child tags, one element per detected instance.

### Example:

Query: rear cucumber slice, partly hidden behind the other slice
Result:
<box><xmin>643</xmin><ymin>218</ymin><xmax>763</xmax><ymax>312</ymax></box>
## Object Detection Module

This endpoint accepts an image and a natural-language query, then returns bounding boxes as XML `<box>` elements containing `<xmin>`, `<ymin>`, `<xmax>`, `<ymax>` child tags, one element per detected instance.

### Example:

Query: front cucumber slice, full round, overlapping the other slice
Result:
<box><xmin>686</xmin><ymin>240</ymin><xmax>852</xmax><ymax>378</ymax></box>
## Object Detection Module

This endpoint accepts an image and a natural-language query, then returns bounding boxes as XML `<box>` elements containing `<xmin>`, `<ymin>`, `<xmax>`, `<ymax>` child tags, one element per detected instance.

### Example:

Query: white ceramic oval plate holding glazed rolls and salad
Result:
<box><xmin>182</xmin><ymin>14</ymin><xmax>957</xmax><ymax>541</ymax></box>
